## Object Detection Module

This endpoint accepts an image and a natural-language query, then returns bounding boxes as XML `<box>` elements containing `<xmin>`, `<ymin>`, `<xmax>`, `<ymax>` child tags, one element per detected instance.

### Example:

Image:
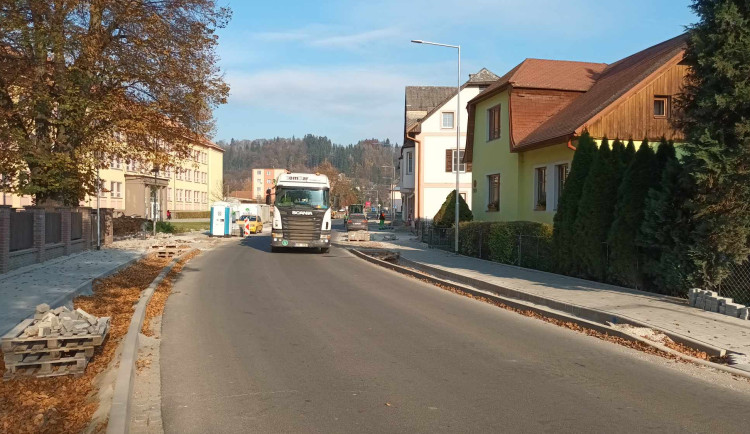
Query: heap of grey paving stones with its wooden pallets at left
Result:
<box><xmin>0</xmin><ymin>304</ymin><xmax>110</xmax><ymax>380</ymax></box>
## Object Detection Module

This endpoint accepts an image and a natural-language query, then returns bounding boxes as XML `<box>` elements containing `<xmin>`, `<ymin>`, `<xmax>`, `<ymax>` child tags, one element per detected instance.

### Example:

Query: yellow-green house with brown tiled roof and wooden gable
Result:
<box><xmin>465</xmin><ymin>35</ymin><xmax>687</xmax><ymax>223</ymax></box>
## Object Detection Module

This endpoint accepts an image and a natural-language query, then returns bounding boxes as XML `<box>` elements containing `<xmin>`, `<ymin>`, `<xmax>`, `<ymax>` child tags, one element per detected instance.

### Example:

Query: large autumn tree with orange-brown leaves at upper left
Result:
<box><xmin>0</xmin><ymin>0</ymin><xmax>230</xmax><ymax>205</ymax></box>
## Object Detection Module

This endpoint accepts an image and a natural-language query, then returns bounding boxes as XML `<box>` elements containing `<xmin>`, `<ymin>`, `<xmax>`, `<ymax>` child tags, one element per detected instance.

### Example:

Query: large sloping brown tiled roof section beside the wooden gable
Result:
<box><xmin>517</xmin><ymin>34</ymin><xmax>688</xmax><ymax>148</ymax></box>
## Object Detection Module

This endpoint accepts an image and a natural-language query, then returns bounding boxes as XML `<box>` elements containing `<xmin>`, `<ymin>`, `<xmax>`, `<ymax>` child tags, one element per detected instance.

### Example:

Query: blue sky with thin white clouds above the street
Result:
<box><xmin>214</xmin><ymin>0</ymin><xmax>696</xmax><ymax>144</ymax></box>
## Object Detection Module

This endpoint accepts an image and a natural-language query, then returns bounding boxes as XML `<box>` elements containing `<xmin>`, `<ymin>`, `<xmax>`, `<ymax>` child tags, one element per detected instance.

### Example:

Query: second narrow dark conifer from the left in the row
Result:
<box><xmin>575</xmin><ymin>137</ymin><xmax>619</xmax><ymax>280</ymax></box>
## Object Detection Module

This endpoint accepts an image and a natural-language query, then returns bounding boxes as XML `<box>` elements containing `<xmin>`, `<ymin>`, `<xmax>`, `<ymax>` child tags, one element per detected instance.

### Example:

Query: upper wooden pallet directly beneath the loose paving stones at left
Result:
<box><xmin>0</xmin><ymin>317</ymin><xmax>110</xmax><ymax>353</ymax></box>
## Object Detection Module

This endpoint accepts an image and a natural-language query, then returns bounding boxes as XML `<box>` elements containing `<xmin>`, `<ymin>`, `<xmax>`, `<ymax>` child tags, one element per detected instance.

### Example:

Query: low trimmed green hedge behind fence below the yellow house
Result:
<box><xmin>447</xmin><ymin>221</ymin><xmax>553</xmax><ymax>271</ymax></box>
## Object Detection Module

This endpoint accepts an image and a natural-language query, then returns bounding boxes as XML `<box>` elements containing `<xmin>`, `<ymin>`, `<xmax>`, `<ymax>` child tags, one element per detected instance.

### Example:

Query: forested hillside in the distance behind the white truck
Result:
<box><xmin>218</xmin><ymin>134</ymin><xmax>399</xmax><ymax>189</ymax></box>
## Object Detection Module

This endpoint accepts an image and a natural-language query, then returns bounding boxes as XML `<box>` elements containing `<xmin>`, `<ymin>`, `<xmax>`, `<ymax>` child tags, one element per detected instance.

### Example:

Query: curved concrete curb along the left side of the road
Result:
<box><xmin>107</xmin><ymin>249</ymin><xmax>197</xmax><ymax>434</ymax></box>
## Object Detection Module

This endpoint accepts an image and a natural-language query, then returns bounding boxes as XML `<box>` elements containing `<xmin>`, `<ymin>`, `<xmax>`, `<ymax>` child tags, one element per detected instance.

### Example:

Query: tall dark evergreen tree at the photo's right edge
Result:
<box><xmin>677</xmin><ymin>0</ymin><xmax>750</xmax><ymax>287</ymax></box>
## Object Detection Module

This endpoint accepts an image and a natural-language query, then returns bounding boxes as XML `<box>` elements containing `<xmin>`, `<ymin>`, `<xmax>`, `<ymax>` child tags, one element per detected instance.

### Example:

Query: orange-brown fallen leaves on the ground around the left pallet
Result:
<box><xmin>0</xmin><ymin>255</ymin><xmax>168</xmax><ymax>433</ymax></box>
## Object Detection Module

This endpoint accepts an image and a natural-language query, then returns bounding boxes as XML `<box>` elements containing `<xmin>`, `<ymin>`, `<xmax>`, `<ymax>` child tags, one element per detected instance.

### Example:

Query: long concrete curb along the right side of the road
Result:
<box><xmin>346</xmin><ymin>248</ymin><xmax>750</xmax><ymax>379</ymax></box>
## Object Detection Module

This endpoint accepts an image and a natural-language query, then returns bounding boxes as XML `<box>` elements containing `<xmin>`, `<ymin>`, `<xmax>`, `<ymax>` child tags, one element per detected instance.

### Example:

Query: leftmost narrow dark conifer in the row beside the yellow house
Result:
<box><xmin>552</xmin><ymin>131</ymin><xmax>596</xmax><ymax>274</ymax></box>
